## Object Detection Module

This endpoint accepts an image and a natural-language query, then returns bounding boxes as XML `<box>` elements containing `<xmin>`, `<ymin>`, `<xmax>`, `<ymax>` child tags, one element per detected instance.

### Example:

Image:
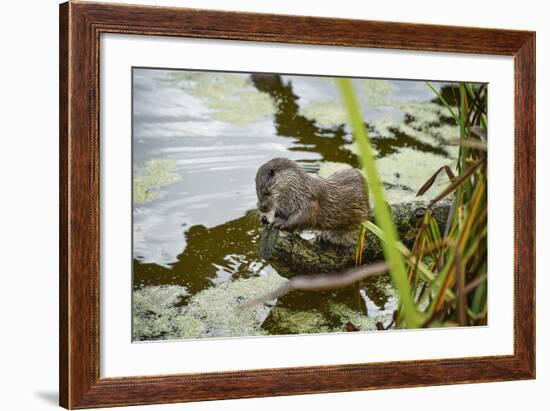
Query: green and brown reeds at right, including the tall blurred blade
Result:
<box><xmin>337</xmin><ymin>79</ymin><xmax>487</xmax><ymax>328</ymax></box>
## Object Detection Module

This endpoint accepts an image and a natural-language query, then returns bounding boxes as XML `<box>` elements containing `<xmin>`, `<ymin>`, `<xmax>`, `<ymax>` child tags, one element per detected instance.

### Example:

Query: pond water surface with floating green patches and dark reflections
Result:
<box><xmin>132</xmin><ymin>68</ymin><xmax>459</xmax><ymax>340</ymax></box>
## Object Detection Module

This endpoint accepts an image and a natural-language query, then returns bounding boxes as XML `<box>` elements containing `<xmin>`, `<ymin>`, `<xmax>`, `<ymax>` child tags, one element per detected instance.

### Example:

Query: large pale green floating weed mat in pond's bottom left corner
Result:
<box><xmin>134</xmin><ymin>273</ymin><xmax>287</xmax><ymax>340</ymax></box>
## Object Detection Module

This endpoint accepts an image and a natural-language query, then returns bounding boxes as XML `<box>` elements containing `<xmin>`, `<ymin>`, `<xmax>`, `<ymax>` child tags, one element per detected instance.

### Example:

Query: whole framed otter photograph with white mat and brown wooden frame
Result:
<box><xmin>60</xmin><ymin>2</ymin><xmax>535</xmax><ymax>409</ymax></box>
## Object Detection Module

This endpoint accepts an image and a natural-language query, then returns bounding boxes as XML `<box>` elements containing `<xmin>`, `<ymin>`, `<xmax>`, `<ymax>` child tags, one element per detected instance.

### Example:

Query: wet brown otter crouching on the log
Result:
<box><xmin>256</xmin><ymin>158</ymin><xmax>370</xmax><ymax>246</ymax></box>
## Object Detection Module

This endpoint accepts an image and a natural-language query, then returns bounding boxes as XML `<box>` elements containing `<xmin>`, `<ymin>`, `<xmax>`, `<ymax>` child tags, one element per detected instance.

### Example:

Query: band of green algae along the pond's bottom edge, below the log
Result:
<box><xmin>133</xmin><ymin>273</ymin><xmax>402</xmax><ymax>340</ymax></box>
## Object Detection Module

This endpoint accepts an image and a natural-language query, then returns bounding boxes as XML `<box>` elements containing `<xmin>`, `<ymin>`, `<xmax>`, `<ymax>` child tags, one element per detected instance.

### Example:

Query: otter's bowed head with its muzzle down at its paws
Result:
<box><xmin>256</xmin><ymin>158</ymin><xmax>299</xmax><ymax>224</ymax></box>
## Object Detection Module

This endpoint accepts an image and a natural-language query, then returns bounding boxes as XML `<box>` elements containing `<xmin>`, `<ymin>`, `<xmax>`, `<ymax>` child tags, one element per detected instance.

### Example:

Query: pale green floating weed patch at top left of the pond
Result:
<box><xmin>164</xmin><ymin>72</ymin><xmax>276</xmax><ymax>126</ymax></box>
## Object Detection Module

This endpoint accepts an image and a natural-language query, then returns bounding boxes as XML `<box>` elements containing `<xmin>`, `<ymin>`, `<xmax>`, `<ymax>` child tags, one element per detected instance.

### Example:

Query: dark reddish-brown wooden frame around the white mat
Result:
<box><xmin>59</xmin><ymin>2</ymin><xmax>535</xmax><ymax>408</ymax></box>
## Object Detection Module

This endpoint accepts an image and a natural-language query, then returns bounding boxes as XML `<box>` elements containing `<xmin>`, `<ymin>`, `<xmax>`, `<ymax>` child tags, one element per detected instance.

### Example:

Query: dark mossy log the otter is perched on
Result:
<box><xmin>259</xmin><ymin>201</ymin><xmax>451</xmax><ymax>278</ymax></box>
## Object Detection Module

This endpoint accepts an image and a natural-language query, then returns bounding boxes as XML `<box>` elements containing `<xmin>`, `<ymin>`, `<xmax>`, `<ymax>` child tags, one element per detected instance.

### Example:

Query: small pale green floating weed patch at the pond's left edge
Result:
<box><xmin>133</xmin><ymin>160</ymin><xmax>179</xmax><ymax>204</ymax></box>
